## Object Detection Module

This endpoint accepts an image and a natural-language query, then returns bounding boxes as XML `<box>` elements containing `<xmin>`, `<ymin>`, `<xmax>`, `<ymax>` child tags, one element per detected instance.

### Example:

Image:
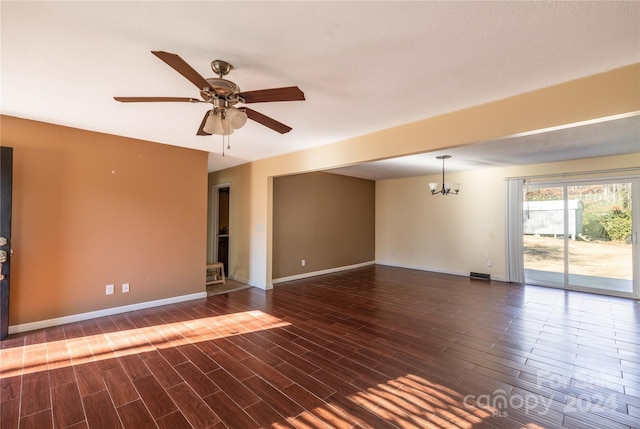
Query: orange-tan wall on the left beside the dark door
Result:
<box><xmin>0</xmin><ymin>116</ymin><xmax>207</xmax><ymax>325</ymax></box>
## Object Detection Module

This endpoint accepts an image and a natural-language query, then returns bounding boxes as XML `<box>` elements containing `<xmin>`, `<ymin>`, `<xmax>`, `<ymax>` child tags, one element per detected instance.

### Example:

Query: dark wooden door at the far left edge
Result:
<box><xmin>0</xmin><ymin>147</ymin><xmax>13</xmax><ymax>340</ymax></box>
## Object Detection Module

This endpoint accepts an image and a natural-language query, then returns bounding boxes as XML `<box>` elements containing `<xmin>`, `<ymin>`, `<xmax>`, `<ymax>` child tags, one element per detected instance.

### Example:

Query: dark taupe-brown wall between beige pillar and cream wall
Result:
<box><xmin>273</xmin><ymin>172</ymin><xmax>375</xmax><ymax>280</ymax></box>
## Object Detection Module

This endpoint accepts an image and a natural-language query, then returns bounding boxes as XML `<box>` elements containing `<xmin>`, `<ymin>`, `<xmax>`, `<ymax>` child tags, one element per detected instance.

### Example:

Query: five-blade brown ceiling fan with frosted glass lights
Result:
<box><xmin>113</xmin><ymin>51</ymin><xmax>305</xmax><ymax>136</ymax></box>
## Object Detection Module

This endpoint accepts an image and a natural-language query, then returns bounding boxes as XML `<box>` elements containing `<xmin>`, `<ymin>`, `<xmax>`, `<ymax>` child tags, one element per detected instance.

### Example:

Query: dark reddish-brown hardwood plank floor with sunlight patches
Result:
<box><xmin>0</xmin><ymin>266</ymin><xmax>640</xmax><ymax>429</ymax></box>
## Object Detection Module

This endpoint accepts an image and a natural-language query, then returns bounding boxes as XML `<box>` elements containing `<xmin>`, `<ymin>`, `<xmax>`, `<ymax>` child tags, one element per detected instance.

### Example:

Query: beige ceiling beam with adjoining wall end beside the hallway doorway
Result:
<box><xmin>209</xmin><ymin>64</ymin><xmax>640</xmax><ymax>288</ymax></box>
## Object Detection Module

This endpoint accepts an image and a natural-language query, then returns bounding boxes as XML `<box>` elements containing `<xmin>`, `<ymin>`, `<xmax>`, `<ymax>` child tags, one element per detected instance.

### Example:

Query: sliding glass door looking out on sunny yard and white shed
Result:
<box><xmin>522</xmin><ymin>178</ymin><xmax>640</xmax><ymax>297</ymax></box>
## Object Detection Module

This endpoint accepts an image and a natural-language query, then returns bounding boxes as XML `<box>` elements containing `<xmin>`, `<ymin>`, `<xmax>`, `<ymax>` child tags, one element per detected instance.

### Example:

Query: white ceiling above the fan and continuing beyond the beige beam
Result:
<box><xmin>0</xmin><ymin>0</ymin><xmax>640</xmax><ymax>178</ymax></box>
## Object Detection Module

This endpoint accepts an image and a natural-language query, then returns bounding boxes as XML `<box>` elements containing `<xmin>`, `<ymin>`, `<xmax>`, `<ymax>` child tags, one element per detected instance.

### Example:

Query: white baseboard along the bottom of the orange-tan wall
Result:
<box><xmin>9</xmin><ymin>292</ymin><xmax>207</xmax><ymax>335</ymax></box>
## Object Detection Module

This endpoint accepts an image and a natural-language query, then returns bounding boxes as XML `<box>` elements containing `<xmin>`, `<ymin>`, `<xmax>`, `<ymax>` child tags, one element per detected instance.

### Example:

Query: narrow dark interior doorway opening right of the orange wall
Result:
<box><xmin>212</xmin><ymin>184</ymin><xmax>231</xmax><ymax>277</ymax></box>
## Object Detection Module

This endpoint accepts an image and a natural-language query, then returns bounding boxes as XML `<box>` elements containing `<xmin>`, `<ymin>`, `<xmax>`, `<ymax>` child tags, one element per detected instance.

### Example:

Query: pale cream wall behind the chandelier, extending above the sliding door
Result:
<box><xmin>376</xmin><ymin>153</ymin><xmax>640</xmax><ymax>280</ymax></box>
